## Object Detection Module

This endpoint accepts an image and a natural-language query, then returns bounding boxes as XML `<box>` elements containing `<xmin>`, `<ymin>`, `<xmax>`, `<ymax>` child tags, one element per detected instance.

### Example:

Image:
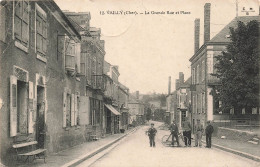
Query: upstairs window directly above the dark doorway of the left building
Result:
<box><xmin>36</xmin><ymin>4</ymin><xmax>47</xmax><ymax>57</ymax></box>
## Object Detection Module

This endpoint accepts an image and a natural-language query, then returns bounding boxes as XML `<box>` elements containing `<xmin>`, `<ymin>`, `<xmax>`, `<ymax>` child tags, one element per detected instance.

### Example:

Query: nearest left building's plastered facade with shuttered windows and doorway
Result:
<box><xmin>0</xmin><ymin>0</ymin><xmax>85</xmax><ymax>164</ymax></box>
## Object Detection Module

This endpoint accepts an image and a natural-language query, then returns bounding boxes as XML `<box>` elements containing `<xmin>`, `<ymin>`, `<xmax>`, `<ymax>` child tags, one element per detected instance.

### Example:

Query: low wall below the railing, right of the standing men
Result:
<box><xmin>217</xmin><ymin>127</ymin><xmax>257</xmax><ymax>141</ymax></box>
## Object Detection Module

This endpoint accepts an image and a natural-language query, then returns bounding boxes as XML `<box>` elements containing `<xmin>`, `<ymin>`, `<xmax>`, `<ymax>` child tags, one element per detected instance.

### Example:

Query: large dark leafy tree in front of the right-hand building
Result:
<box><xmin>214</xmin><ymin>20</ymin><xmax>260</xmax><ymax>112</ymax></box>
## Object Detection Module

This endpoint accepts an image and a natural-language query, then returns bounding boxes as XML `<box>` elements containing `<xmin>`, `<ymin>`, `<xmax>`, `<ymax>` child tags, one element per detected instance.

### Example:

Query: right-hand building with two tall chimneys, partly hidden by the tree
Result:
<box><xmin>190</xmin><ymin>3</ymin><xmax>259</xmax><ymax>130</ymax></box>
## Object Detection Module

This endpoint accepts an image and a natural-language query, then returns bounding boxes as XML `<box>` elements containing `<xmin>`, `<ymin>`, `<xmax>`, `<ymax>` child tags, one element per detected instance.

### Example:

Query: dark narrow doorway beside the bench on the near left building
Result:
<box><xmin>36</xmin><ymin>86</ymin><xmax>46</xmax><ymax>148</ymax></box>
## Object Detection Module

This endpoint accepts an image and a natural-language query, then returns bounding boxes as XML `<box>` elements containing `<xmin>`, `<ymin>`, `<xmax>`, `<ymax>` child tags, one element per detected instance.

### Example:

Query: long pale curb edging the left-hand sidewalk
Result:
<box><xmin>62</xmin><ymin>127</ymin><xmax>139</xmax><ymax>167</ymax></box>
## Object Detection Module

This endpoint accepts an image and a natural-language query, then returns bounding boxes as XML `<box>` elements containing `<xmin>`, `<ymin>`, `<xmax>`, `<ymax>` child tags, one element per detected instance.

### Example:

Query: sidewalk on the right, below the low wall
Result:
<box><xmin>202</xmin><ymin>136</ymin><xmax>260</xmax><ymax>162</ymax></box>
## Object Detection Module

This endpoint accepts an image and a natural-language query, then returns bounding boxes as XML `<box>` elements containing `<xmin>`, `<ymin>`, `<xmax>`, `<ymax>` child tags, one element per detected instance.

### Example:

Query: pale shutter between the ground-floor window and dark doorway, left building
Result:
<box><xmin>28</xmin><ymin>81</ymin><xmax>34</xmax><ymax>133</ymax></box>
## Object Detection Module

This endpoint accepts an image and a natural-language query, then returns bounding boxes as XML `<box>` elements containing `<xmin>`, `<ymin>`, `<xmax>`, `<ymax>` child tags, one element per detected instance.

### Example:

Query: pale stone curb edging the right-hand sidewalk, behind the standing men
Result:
<box><xmin>202</xmin><ymin>140</ymin><xmax>260</xmax><ymax>162</ymax></box>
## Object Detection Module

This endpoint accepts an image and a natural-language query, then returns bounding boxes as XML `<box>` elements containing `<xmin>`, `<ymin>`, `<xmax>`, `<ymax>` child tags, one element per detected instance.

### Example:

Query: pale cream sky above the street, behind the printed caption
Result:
<box><xmin>54</xmin><ymin>0</ymin><xmax>260</xmax><ymax>94</ymax></box>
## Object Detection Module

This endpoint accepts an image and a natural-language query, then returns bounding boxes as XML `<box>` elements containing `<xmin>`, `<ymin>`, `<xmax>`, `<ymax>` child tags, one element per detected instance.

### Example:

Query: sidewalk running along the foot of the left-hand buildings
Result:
<box><xmin>18</xmin><ymin>127</ymin><xmax>138</xmax><ymax>167</ymax></box>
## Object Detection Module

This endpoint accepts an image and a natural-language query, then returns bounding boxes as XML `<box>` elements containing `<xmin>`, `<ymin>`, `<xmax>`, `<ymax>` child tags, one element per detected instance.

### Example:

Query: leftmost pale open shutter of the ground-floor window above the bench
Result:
<box><xmin>10</xmin><ymin>75</ymin><xmax>17</xmax><ymax>137</ymax></box>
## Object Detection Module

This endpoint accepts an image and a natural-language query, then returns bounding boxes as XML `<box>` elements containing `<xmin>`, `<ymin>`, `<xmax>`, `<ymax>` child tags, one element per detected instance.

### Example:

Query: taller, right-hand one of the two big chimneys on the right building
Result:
<box><xmin>204</xmin><ymin>3</ymin><xmax>211</xmax><ymax>43</ymax></box>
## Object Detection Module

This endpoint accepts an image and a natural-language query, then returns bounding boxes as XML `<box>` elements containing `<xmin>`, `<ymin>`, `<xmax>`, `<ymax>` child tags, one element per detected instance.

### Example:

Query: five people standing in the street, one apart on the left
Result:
<box><xmin>147</xmin><ymin>118</ymin><xmax>214</xmax><ymax>148</ymax></box>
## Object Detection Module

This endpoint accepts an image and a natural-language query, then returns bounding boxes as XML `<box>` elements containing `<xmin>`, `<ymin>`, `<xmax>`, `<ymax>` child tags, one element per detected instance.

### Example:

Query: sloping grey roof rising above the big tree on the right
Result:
<box><xmin>209</xmin><ymin>16</ymin><xmax>260</xmax><ymax>43</ymax></box>
